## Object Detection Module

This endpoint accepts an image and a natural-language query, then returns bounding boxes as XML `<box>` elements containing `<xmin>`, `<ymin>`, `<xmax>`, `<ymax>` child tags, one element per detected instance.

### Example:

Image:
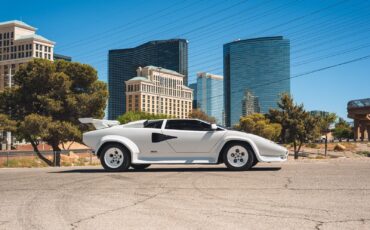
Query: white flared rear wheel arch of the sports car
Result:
<box><xmin>96</xmin><ymin>135</ymin><xmax>139</xmax><ymax>161</ymax></box>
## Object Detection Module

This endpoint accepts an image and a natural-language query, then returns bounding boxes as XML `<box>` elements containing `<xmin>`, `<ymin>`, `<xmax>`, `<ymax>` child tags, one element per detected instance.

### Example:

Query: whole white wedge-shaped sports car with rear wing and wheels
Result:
<box><xmin>80</xmin><ymin>118</ymin><xmax>288</xmax><ymax>171</ymax></box>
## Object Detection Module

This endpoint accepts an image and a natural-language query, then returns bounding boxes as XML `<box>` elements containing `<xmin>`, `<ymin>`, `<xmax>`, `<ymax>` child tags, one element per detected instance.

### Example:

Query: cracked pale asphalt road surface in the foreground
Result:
<box><xmin>0</xmin><ymin>159</ymin><xmax>370</xmax><ymax>230</ymax></box>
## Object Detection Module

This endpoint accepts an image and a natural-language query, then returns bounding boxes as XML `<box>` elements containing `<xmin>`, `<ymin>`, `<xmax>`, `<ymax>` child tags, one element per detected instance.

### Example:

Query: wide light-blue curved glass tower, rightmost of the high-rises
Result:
<box><xmin>224</xmin><ymin>36</ymin><xmax>290</xmax><ymax>126</ymax></box>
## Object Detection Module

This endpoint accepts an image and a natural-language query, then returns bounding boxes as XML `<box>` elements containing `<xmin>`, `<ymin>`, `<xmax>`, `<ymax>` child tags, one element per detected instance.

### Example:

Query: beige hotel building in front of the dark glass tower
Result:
<box><xmin>125</xmin><ymin>66</ymin><xmax>193</xmax><ymax>118</ymax></box>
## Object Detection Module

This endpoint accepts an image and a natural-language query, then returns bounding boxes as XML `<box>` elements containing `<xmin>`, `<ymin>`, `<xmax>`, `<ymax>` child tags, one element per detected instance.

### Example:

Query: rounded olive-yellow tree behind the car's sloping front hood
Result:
<box><xmin>236</xmin><ymin>113</ymin><xmax>281</xmax><ymax>141</ymax></box>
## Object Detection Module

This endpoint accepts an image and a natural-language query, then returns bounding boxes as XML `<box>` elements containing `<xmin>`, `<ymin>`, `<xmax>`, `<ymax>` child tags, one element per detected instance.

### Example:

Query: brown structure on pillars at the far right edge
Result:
<box><xmin>347</xmin><ymin>98</ymin><xmax>370</xmax><ymax>141</ymax></box>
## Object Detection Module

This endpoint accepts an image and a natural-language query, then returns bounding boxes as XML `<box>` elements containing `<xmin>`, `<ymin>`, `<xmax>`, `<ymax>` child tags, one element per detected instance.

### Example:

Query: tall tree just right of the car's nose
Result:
<box><xmin>267</xmin><ymin>94</ymin><xmax>318</xmax><ymax>159</ymax></box>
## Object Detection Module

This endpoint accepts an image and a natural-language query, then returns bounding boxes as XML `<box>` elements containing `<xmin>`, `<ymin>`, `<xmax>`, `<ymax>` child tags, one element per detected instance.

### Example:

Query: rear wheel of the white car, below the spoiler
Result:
<box><xmin>100</xmin><ymin>143</ymin><xmax>131</xmax><ymax>172</ymax></box>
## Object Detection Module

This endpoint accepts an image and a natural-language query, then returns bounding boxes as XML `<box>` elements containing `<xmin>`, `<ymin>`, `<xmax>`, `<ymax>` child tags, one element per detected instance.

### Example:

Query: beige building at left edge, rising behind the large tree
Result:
<box><xmin>0</xmin><ymin>20</ymin><xmax>55</xmax><ymax>91</ymax></box>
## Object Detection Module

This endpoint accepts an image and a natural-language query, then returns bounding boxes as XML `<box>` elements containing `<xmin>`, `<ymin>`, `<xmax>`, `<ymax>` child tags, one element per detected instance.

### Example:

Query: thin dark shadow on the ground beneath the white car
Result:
<box><xmin>50</xmin><ymin>167</ymin><xmax>281</xmax><ymax>173</ymax></box>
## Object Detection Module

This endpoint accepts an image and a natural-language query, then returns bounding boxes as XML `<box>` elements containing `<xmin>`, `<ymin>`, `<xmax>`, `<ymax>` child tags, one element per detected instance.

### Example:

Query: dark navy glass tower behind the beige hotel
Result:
<box><xmin>108</xmin><ymin>39</ymin><xmax>188</xmax><ymax>119</ymax></box>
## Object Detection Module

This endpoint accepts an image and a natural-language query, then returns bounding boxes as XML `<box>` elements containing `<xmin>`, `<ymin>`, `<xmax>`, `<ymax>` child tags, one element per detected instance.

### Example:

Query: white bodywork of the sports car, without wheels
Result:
<box><xmin>83</xmin><ymin>119</ymin><xmax>288</xmax><ymax>164</ymax></box>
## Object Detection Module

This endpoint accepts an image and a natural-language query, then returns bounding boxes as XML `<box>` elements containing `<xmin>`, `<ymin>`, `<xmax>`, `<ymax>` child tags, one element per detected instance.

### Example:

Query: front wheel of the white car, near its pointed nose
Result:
<box><xmin>222</xmin><ymin>142</ymin><xmax>255</xmax><ymax>171</ymax></box>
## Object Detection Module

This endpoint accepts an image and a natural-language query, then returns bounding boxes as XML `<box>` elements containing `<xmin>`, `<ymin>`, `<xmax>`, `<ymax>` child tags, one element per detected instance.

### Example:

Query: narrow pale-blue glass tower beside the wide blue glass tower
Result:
<box><xmin>197</xmin><ymin>72</ymin><xmax>224</xmax><ymax>124</ymax></box>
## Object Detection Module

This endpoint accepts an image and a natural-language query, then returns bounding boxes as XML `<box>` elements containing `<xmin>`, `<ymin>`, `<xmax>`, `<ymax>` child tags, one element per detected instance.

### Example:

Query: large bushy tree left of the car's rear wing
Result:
<box><xmin>0</xmin><ymin>59</ymin><xmax>108</xmax><ymax>166</ymax></box>
